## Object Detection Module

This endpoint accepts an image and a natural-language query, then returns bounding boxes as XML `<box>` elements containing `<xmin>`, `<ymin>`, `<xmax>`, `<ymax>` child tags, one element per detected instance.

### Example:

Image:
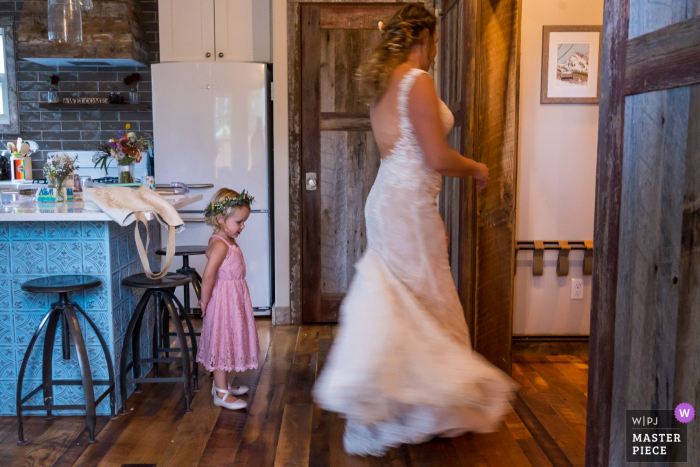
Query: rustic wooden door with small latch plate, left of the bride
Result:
<box><xmin>300</xmin><ymin>3</ymin><xmax>401</xmax><ymax>323</ymax></box>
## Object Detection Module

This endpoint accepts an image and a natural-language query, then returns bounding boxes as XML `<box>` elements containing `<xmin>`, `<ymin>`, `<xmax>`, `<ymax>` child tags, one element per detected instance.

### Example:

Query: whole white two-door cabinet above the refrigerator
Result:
<box><xmin>158</xmin><ymin>0</ymin><xmax>272</xmax><ymax>63</ymax></box>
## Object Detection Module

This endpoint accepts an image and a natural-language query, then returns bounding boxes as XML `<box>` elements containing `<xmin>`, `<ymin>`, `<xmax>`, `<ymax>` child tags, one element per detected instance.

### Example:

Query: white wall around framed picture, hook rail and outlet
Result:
<box><xmin>513</xmin><ymin>0</ymin><xmax>603</xmax><ymax>335</ymax></box>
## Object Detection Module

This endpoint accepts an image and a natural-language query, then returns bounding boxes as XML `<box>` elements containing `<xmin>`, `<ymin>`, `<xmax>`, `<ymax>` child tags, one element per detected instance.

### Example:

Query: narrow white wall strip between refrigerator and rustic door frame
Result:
<box><xmin>272</xmin><ymin>0</ymin><xmax>289</xmax><ymax>307</ymax></box>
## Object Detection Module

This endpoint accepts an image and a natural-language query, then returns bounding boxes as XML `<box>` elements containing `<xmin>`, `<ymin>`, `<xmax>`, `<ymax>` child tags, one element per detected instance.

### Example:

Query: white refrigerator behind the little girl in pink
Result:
<box><xmin>151</xmin><ymin>62</ymin><xmax>274</xmax><ymax>315</ymax></box>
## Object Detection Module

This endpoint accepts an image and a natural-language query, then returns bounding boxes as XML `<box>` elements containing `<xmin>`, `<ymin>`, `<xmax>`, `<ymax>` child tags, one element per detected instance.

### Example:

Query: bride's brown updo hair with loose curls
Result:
<box><xmin>357</xmin><ymin>3</ymin><xmax>437</xmax><ymax>103</ymax></box>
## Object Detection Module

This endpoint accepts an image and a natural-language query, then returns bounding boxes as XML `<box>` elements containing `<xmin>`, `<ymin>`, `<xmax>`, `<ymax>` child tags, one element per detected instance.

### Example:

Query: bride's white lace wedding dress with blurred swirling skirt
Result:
<box><xmin>314</xmin><ymin>69</ymin><xmax>517</xmax><ymax>456</ymax></box>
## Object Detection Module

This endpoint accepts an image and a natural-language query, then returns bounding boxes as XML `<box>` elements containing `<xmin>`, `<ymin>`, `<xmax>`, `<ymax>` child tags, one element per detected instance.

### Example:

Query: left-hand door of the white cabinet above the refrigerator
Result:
<box><xmin>158</xmin><ymin>0</ymin><xmax>216</xmax><ymax>62</ymax></box>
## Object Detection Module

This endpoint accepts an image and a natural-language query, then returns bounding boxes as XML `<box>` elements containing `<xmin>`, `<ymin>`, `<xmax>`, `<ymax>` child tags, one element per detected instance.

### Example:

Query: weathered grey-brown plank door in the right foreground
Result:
<box><xmin>586</xmin><ymin>0</ymin><xmax>700</xmax><ymax>467</ymax></box>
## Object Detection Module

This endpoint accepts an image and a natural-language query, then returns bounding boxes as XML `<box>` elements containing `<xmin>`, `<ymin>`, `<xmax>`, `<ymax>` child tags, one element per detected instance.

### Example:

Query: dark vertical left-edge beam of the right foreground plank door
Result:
<box><xmin>586</xmin><ymin>0</ymin><xmax>630</xmax><ymax>467</ymax></box>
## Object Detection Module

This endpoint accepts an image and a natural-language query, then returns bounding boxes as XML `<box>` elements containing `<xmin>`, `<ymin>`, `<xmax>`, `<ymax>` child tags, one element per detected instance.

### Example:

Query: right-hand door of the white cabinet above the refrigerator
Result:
<box><xmin>214</xmin><ymin>0</ymin><xmax>272</xmax><ymax>63</ymax></box>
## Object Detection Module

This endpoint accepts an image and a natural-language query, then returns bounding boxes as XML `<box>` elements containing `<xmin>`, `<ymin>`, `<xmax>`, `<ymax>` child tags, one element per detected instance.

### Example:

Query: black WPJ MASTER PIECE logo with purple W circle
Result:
<box><xmin>626</xmin><ymin>403</ymin><xmax>695</xmax><ymax>462</ymax></box>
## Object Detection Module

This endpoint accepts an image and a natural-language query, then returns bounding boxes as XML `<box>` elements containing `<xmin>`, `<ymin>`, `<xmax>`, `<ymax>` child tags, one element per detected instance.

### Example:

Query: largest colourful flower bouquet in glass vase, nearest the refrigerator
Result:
<box><xmin>92</xmin><ymin>124</ymin><xmax>151</xmax><ymax>183</ymax></box>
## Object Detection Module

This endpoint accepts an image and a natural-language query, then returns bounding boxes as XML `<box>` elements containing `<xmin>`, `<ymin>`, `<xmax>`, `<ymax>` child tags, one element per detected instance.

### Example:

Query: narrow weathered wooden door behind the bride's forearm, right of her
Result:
<box><xmin>438</xmin><ymin>0</ymin><xmax>476</xmax><ymax>341</ymax></box>
